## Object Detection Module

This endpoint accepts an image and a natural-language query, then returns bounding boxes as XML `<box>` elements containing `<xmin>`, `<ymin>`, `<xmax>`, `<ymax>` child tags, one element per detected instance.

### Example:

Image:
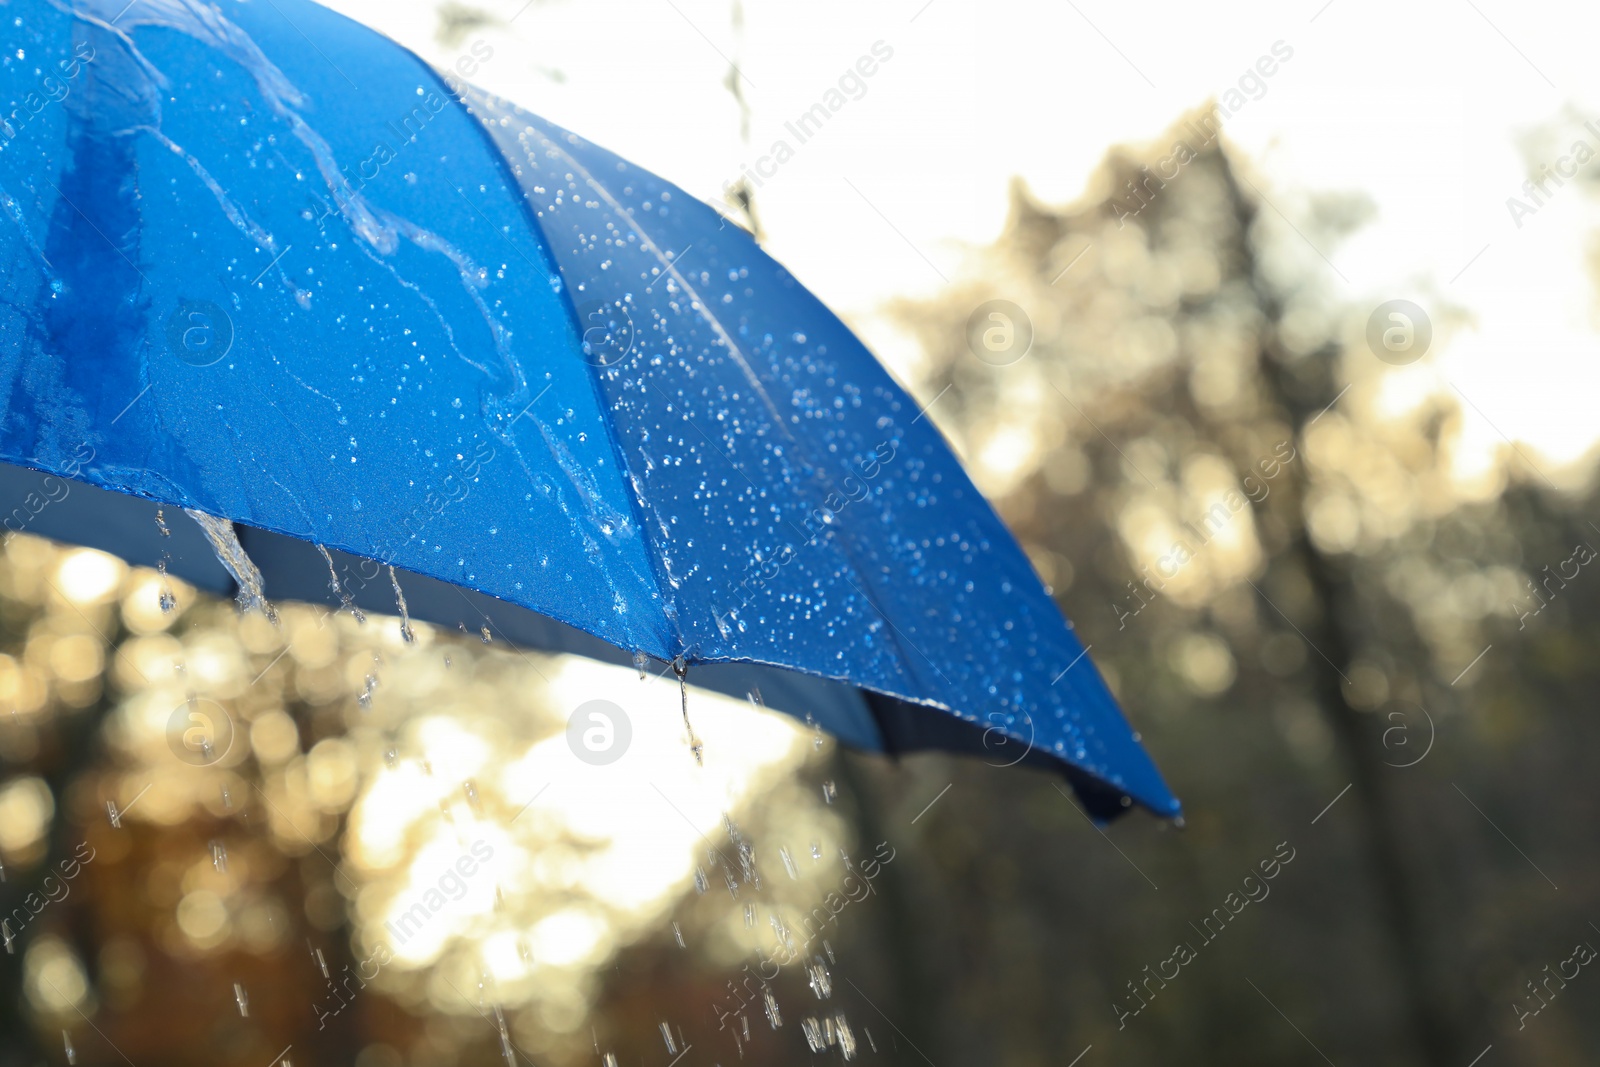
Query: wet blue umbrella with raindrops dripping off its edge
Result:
<box><xmin>0</xmin><ymin>0</ymin><xmax>1178</xmax><ymax>817</ymax></box>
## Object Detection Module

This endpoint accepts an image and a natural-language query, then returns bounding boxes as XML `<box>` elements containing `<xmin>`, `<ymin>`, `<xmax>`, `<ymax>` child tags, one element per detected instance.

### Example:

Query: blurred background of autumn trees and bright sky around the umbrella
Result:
<box><xmin>0</xmin><ymin>0</ymin><xmax>1600</xmax><ymax>1067</ymax></box>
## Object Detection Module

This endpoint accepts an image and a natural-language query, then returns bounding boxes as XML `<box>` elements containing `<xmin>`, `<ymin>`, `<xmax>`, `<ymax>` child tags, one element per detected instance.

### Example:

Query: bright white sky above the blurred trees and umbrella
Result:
<box><xmin>318</xmin><ymin>0</ymin><xmax>1600</xmax><ymax>477</ymax></box>
